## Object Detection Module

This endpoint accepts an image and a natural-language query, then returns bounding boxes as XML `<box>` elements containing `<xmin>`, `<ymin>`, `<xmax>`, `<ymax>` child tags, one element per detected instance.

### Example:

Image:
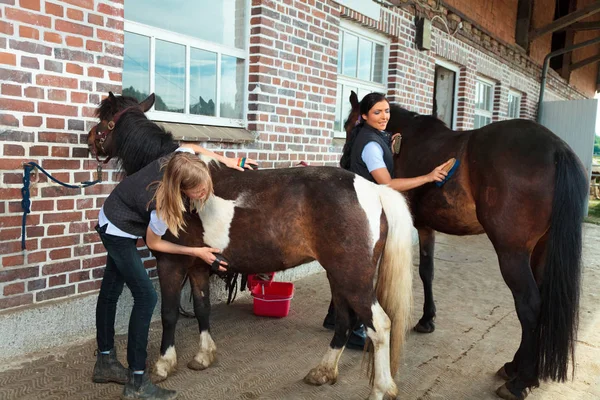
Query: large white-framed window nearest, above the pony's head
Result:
<box><xmin>123</xmin><ymin>0</ymin><xmax>248</xmax><ymax>126</ymax></box>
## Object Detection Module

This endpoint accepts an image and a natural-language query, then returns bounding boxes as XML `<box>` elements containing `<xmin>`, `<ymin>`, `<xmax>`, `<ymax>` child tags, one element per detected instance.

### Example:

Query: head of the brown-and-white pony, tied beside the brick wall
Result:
<box><xmin>88</xmin><ymin>92</ymin><xmax>154</xmax><ymax>163</ymax></box>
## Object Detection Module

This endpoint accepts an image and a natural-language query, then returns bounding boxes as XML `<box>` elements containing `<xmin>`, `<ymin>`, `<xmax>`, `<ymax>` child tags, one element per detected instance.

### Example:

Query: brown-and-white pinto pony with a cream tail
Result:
<box><xmin>88</xmin><ymin>93</ymin><xmax>412</xmax><ymax>399</ymax></box>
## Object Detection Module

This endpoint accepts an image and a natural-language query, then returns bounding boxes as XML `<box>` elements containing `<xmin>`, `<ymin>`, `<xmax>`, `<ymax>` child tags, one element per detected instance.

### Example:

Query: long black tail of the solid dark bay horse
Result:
<box><xmin>536</xmin><ymin>146</ymin><xmax>588</xmax><ymax>382</ymax></box>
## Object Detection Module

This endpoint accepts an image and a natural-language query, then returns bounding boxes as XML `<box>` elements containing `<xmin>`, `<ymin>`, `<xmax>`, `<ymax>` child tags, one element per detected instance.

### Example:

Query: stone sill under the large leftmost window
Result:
<box><xmin>156</xmin><ymin>121</ymin><xmax>256</xmax><ymax>144</ymax></box>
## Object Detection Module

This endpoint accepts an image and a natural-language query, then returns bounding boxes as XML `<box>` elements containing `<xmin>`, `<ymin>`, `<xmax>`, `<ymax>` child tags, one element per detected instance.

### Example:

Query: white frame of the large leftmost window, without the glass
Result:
<box><xmin>124</xmin><ymin>7</ymin><xmax>251</xmax><ymax>128</ymax></box>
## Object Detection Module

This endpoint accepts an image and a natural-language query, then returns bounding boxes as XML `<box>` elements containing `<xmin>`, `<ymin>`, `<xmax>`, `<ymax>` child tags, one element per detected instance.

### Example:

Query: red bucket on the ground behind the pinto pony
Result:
<box><xmin>252</xmin><ymin>282</ymin><xmax>294</xmax><ymax>318</ymax></box>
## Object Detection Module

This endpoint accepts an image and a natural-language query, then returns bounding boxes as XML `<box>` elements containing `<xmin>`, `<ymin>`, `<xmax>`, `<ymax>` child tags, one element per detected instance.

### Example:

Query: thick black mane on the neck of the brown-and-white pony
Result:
<box><xmin>112</xmin><ymin>109</ymin><xmax>177</xmax><ymax>175</ymax></box>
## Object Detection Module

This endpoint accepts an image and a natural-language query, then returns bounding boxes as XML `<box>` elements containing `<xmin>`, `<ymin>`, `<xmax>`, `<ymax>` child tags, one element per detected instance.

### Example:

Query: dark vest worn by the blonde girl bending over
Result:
<box><xmin>104</xmin><ymin>159</ymin><xmax>164</xmax><ymax>237</ymax></box>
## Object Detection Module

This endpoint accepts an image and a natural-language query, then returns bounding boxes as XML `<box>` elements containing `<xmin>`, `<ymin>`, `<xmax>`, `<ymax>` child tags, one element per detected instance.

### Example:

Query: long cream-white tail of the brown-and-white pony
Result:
<box><xmin>369</xmin><ymin>186</ymin><xmax>412</xmax><ymax>377</ymax></box>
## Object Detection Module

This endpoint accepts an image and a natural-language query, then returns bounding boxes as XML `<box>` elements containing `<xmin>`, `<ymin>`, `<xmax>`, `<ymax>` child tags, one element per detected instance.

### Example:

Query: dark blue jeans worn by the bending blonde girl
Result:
<box><xmin>96</xmin><ymin>225</ymin><xmax>158</xmax><ymax>371</ymax></box>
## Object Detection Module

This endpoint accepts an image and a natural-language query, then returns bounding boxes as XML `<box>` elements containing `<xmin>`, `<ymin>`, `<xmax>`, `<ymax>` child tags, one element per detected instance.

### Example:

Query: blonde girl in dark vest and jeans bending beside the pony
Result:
<box><xmin>92</xmin><ymin>145</ymin><xmax>256</xmax><ymax>400</ymax></box>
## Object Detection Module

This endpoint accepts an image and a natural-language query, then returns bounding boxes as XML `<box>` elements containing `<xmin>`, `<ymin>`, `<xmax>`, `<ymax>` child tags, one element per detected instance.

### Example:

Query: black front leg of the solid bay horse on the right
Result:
<box><xmin>415</xmin><ymin>227</ymin><xmax>435</xmax><ymax>333</ymax></box>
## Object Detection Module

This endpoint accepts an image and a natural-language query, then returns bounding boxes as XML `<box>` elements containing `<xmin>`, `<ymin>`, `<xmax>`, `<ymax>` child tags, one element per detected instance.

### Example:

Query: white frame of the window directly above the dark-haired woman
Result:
<box><xmin>333</xmin><ymin>20</ymin><xmax>390</xmax><ymax>138</ymax></box>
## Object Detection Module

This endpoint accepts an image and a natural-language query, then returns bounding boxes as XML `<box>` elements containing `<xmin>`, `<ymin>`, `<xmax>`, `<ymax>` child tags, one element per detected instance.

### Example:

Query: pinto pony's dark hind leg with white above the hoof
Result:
<box><xmin>304</xmin><ymin>273</ymin><xmax>352</xmax><ymax>386</ymax></box>
